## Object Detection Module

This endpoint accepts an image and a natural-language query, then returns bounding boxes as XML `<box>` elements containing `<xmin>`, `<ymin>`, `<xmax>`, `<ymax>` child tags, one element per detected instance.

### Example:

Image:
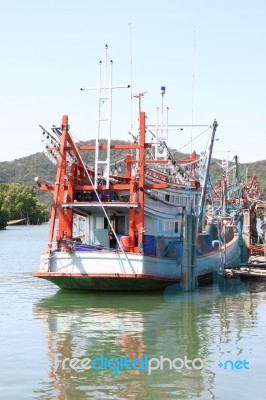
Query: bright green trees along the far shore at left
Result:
<box><xmin>0</xmin><ymin>183</ymin><xmax>49</xmax><ymax>229</ymax></box>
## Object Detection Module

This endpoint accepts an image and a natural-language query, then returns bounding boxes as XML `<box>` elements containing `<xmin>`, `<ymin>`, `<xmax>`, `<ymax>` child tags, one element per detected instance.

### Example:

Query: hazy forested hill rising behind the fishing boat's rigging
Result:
<box><xmin>0</xmin><ymin>147</ymin><xmax>266</xmax><ymax>206</ymax></box>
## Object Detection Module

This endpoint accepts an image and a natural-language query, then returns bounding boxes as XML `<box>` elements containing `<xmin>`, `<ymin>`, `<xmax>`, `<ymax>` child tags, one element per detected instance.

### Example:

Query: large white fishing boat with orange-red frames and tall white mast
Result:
<box><xmin>33</xmin><ymin>48</ymin><xmax>240</xmax><ymax>291</ymax></box>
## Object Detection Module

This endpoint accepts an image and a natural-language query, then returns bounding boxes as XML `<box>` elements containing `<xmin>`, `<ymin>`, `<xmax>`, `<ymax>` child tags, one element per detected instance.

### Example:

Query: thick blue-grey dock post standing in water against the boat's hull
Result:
<box><xmin>181</xmin><ymin>213</ymin><xmax>197</xmax><ymax>291</ymax></box>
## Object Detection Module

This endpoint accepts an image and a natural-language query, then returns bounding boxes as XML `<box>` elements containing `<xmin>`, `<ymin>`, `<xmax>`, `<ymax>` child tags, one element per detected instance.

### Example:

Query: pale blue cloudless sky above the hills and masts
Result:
<box><xmin>0</xmin><ymin>0</ymin><xmax>266</xmax><ymax>164</ymax></box>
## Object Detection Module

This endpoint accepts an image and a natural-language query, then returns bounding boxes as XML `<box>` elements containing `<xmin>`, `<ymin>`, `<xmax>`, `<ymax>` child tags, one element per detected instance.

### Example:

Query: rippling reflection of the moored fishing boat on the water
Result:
<box><xmin>33</xmin><ymin>286</ymin><xmax>265</xmax><ymax>400</ymax></box>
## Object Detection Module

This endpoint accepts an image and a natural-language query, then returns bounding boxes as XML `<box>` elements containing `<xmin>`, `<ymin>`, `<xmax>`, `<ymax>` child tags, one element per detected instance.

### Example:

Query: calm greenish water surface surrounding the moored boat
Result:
<box><xmin>0</xmin><ymin>226</ymin><xmax>266</xmax><ymax>400</ymax></box>
